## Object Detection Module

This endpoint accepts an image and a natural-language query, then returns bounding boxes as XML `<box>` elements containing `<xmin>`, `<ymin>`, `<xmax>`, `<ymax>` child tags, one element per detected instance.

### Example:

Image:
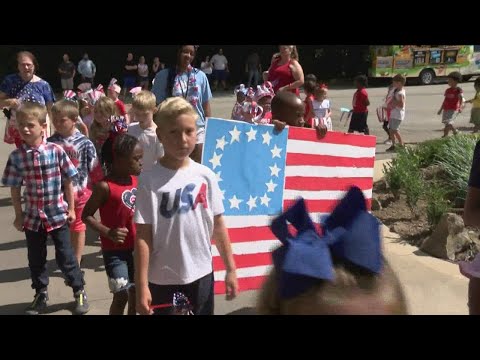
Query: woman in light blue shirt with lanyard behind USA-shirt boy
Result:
<box><xmin>152</xmin><ymin>45</ymin><xmax>212</xmax><ymax>163</ymax></box>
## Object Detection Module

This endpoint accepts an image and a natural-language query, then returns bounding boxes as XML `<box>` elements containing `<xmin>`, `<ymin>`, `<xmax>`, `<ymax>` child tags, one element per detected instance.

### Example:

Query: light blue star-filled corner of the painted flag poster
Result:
<box><xmin>202</xmin><ymin>118</ymin><xmax>288</xmax><ymax>215</ymax></box>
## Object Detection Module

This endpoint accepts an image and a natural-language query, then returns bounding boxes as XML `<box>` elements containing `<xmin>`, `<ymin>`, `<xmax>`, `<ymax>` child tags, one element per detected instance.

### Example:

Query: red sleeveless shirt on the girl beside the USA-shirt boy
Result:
<box><xmin>99</xmin><ymin>176</ymin><xmax>137</xmax><ymax>250</ymax></box>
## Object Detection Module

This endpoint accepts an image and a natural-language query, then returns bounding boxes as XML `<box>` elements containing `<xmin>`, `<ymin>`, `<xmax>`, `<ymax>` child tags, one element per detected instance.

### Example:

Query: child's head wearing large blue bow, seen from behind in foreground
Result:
<box><xmin>257</xmin><ymin>187</ymin><xmax>407</xmax><ymax>315</ymax></box>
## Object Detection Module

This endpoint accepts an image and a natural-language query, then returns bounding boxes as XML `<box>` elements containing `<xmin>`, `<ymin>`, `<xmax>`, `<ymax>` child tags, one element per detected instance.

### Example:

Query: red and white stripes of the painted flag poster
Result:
<box><xmin>212</xmin><ymin>128</ymin><xmax>376</xmax><ymax>294</ymax></box>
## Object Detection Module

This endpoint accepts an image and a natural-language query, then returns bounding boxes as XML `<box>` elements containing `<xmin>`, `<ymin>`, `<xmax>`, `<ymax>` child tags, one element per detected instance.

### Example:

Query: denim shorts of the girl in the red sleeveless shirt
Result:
<box><xmin>102</xmin><ymin>250</ymin><xmax>134</xmax><ymax>294</ymax></box>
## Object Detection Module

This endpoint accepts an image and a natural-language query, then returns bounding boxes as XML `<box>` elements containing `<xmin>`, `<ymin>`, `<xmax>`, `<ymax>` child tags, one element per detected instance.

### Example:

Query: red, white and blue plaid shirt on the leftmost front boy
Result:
<box><xmin>2</xmin><ymin>142</ymin><xmax>78</xmax><ymax>232</ymax></box>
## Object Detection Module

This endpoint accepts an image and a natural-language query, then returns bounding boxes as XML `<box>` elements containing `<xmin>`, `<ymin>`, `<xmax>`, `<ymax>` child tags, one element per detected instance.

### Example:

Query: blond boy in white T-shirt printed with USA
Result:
<box><xmin>134</xmin><ymin>97</ymin><xmax>238</xmax><ymax>315</ymax></box>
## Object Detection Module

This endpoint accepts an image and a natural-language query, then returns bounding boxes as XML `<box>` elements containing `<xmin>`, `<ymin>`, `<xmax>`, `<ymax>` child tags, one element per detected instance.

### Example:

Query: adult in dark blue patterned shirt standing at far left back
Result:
<box><xmin>0</xmin><ymin>51</ymin><xmax>55</xmax><ymax>147</ymax></box>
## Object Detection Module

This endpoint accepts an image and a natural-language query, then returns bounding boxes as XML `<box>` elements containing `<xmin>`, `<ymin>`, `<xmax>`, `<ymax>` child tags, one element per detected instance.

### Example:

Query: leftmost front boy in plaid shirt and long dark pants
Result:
<box><xmin>2</xmin><ymin>102</ymin><xmax>89</xmax><ymax>315</ymax></box>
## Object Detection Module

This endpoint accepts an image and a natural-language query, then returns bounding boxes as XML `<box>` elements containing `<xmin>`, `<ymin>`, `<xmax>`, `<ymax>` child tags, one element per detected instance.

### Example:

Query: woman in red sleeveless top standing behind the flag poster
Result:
<box><xmin>268</xmin><ymin>45</ymin><xmax>304</xmax><ymax>96</ymax></box>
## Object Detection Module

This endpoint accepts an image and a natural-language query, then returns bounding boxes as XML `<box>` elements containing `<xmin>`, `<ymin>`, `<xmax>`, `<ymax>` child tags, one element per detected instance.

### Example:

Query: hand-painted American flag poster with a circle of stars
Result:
<box><xmin>202</xmin><ymin>118</ymin><xmax>376</xmax><ymax>294</ymax></box>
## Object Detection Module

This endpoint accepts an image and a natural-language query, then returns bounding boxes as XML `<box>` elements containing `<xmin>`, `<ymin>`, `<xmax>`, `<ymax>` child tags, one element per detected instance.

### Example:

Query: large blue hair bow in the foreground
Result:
<box><xmin>271</xmin><ymin>187</ymin><xmax>383</xmax><ymax>298</ymax></box>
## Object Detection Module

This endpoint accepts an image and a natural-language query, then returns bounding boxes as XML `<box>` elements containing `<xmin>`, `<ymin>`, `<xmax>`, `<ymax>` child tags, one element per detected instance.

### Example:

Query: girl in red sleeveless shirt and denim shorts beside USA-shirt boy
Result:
<box><xmin>82</xmin><ymin>134</ymin><xmax>143</xmax><ymax>315</ymax></box>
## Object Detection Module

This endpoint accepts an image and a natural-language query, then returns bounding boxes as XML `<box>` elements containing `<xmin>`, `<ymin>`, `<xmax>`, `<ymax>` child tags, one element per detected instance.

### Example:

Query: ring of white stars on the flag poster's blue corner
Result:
<box><xmin>212</xmin><ymin>126</ymin><xmax>283</xmax><ymax>211</ymax></box>
